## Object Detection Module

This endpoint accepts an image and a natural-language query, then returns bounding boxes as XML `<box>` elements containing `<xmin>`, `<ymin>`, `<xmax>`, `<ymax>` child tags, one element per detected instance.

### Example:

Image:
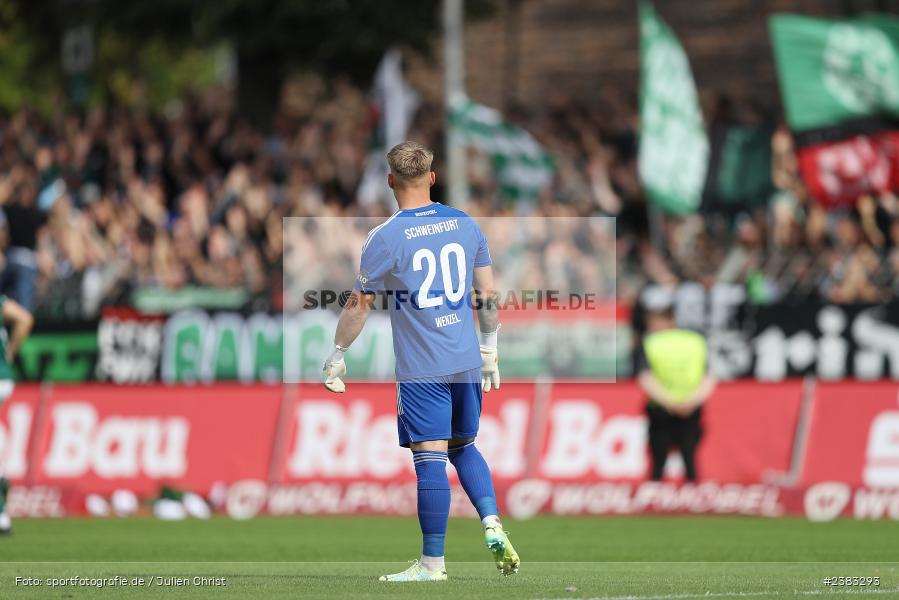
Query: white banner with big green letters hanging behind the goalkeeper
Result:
<box><xmin>157</xmin><ymin>310</ymin><xmax>630</xmax><ymax>383</ymax></box>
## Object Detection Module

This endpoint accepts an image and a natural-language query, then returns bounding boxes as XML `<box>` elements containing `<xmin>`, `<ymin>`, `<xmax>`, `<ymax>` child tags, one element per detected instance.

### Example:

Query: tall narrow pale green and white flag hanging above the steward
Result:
<box><xmin>639</xmin><ymin>2</ymin><xmax>709</xmax><ymax>214</ymax></box>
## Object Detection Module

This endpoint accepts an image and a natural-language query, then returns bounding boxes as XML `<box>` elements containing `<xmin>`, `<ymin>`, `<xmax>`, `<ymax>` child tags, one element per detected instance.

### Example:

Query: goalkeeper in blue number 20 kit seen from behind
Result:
<box><xmin>324</xmin><ymin>142</ymin><xmax>520</xmax><ymax>581</ymax></box>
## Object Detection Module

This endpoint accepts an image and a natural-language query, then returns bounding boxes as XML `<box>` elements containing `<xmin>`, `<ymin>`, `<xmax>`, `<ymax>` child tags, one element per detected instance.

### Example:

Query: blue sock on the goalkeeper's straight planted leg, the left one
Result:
<box><xmin>412</xmin><ymin>450</ymin><xmax>450</xmax><ymax>556</ymax></box>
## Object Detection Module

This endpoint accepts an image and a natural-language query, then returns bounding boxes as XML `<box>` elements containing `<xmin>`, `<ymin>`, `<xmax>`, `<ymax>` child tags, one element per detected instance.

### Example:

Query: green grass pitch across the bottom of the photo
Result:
<box><xmin>0</xmin><ymin>517</ymin><xmax>899</xmax><ymax>600</ymax></box>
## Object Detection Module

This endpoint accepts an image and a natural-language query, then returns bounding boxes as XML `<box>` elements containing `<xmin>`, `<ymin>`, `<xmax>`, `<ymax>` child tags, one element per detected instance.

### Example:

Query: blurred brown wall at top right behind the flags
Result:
<box><xmin>450</xmin><ymin>0</ymin><xmax>899</xmax><ymax>113</ymax></box>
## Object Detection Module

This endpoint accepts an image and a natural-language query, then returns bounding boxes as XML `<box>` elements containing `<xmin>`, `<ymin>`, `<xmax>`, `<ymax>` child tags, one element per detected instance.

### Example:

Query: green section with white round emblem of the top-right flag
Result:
<box><xmin>770</xmin><ymin>15</ymin><xmax>899</xmax><ymax>131</ymax></box>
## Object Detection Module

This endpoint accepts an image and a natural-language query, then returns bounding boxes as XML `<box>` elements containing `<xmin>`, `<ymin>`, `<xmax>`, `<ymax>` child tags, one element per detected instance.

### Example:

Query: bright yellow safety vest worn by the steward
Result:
<box><xmin>643</xmin><ymin>329</ymin><xmax>708</xmax><ymax>401</ymax></box>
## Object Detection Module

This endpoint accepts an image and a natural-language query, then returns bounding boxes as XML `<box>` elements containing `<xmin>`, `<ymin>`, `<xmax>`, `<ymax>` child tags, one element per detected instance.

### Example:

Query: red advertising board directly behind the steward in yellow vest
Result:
<box><xmin>503</xmin><ymin>382</ymin><xmax>801</xmax><ymax>517</ymax></box>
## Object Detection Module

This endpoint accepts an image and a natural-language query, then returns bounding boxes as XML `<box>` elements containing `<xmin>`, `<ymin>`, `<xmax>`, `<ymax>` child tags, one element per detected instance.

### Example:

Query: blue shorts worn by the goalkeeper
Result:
<box><xmin>396</xmin><ymin>367</ymin><xmax>481</xmax><ymax>448</ymax></box>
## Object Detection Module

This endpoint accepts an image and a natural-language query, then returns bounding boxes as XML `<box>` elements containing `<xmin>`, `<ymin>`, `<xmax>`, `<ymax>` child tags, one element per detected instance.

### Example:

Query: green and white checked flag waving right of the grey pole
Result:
<box><xmin>449</xmin><ymin>99</ymin><xmax>554</xmax><ymax>200</ymax></box>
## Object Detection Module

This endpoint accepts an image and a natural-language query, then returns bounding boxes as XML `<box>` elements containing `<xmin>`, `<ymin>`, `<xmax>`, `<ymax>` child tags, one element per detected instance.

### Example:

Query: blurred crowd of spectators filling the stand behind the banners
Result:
<box><xmin>0</xmin><ymin>87</ymin><xmax>899</xmax><ymax>317</ymax></box>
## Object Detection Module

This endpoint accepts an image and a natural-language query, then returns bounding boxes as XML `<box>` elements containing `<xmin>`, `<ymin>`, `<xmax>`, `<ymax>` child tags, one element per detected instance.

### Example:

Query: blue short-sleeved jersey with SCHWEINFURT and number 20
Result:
<box><xmin>355</xmin><ymin>202</ymin><xmax>492</xmax><ymax>381</ymax></box>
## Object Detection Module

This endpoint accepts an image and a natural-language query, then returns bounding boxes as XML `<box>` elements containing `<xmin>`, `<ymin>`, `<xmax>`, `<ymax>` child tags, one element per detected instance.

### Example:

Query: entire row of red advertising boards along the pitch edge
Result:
<box><xmin>0</xmin><ymin>380</ymin><xmax>899</xmax><ymax>520</ymax></box>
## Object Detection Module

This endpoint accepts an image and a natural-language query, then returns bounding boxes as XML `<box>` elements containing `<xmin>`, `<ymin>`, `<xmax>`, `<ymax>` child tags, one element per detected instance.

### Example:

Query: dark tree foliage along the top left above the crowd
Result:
<box><xmin>0</xmin><ymin>0</ymin><xmax>493</xmax><ymax>122</ymax></box>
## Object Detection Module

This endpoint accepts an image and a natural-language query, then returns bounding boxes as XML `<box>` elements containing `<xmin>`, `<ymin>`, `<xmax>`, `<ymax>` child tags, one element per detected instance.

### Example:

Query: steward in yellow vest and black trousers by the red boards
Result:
<box><xmin>635</xmin><ymin>307</ymin><xmax>717</xmax><ymax>481</ymax></box>
